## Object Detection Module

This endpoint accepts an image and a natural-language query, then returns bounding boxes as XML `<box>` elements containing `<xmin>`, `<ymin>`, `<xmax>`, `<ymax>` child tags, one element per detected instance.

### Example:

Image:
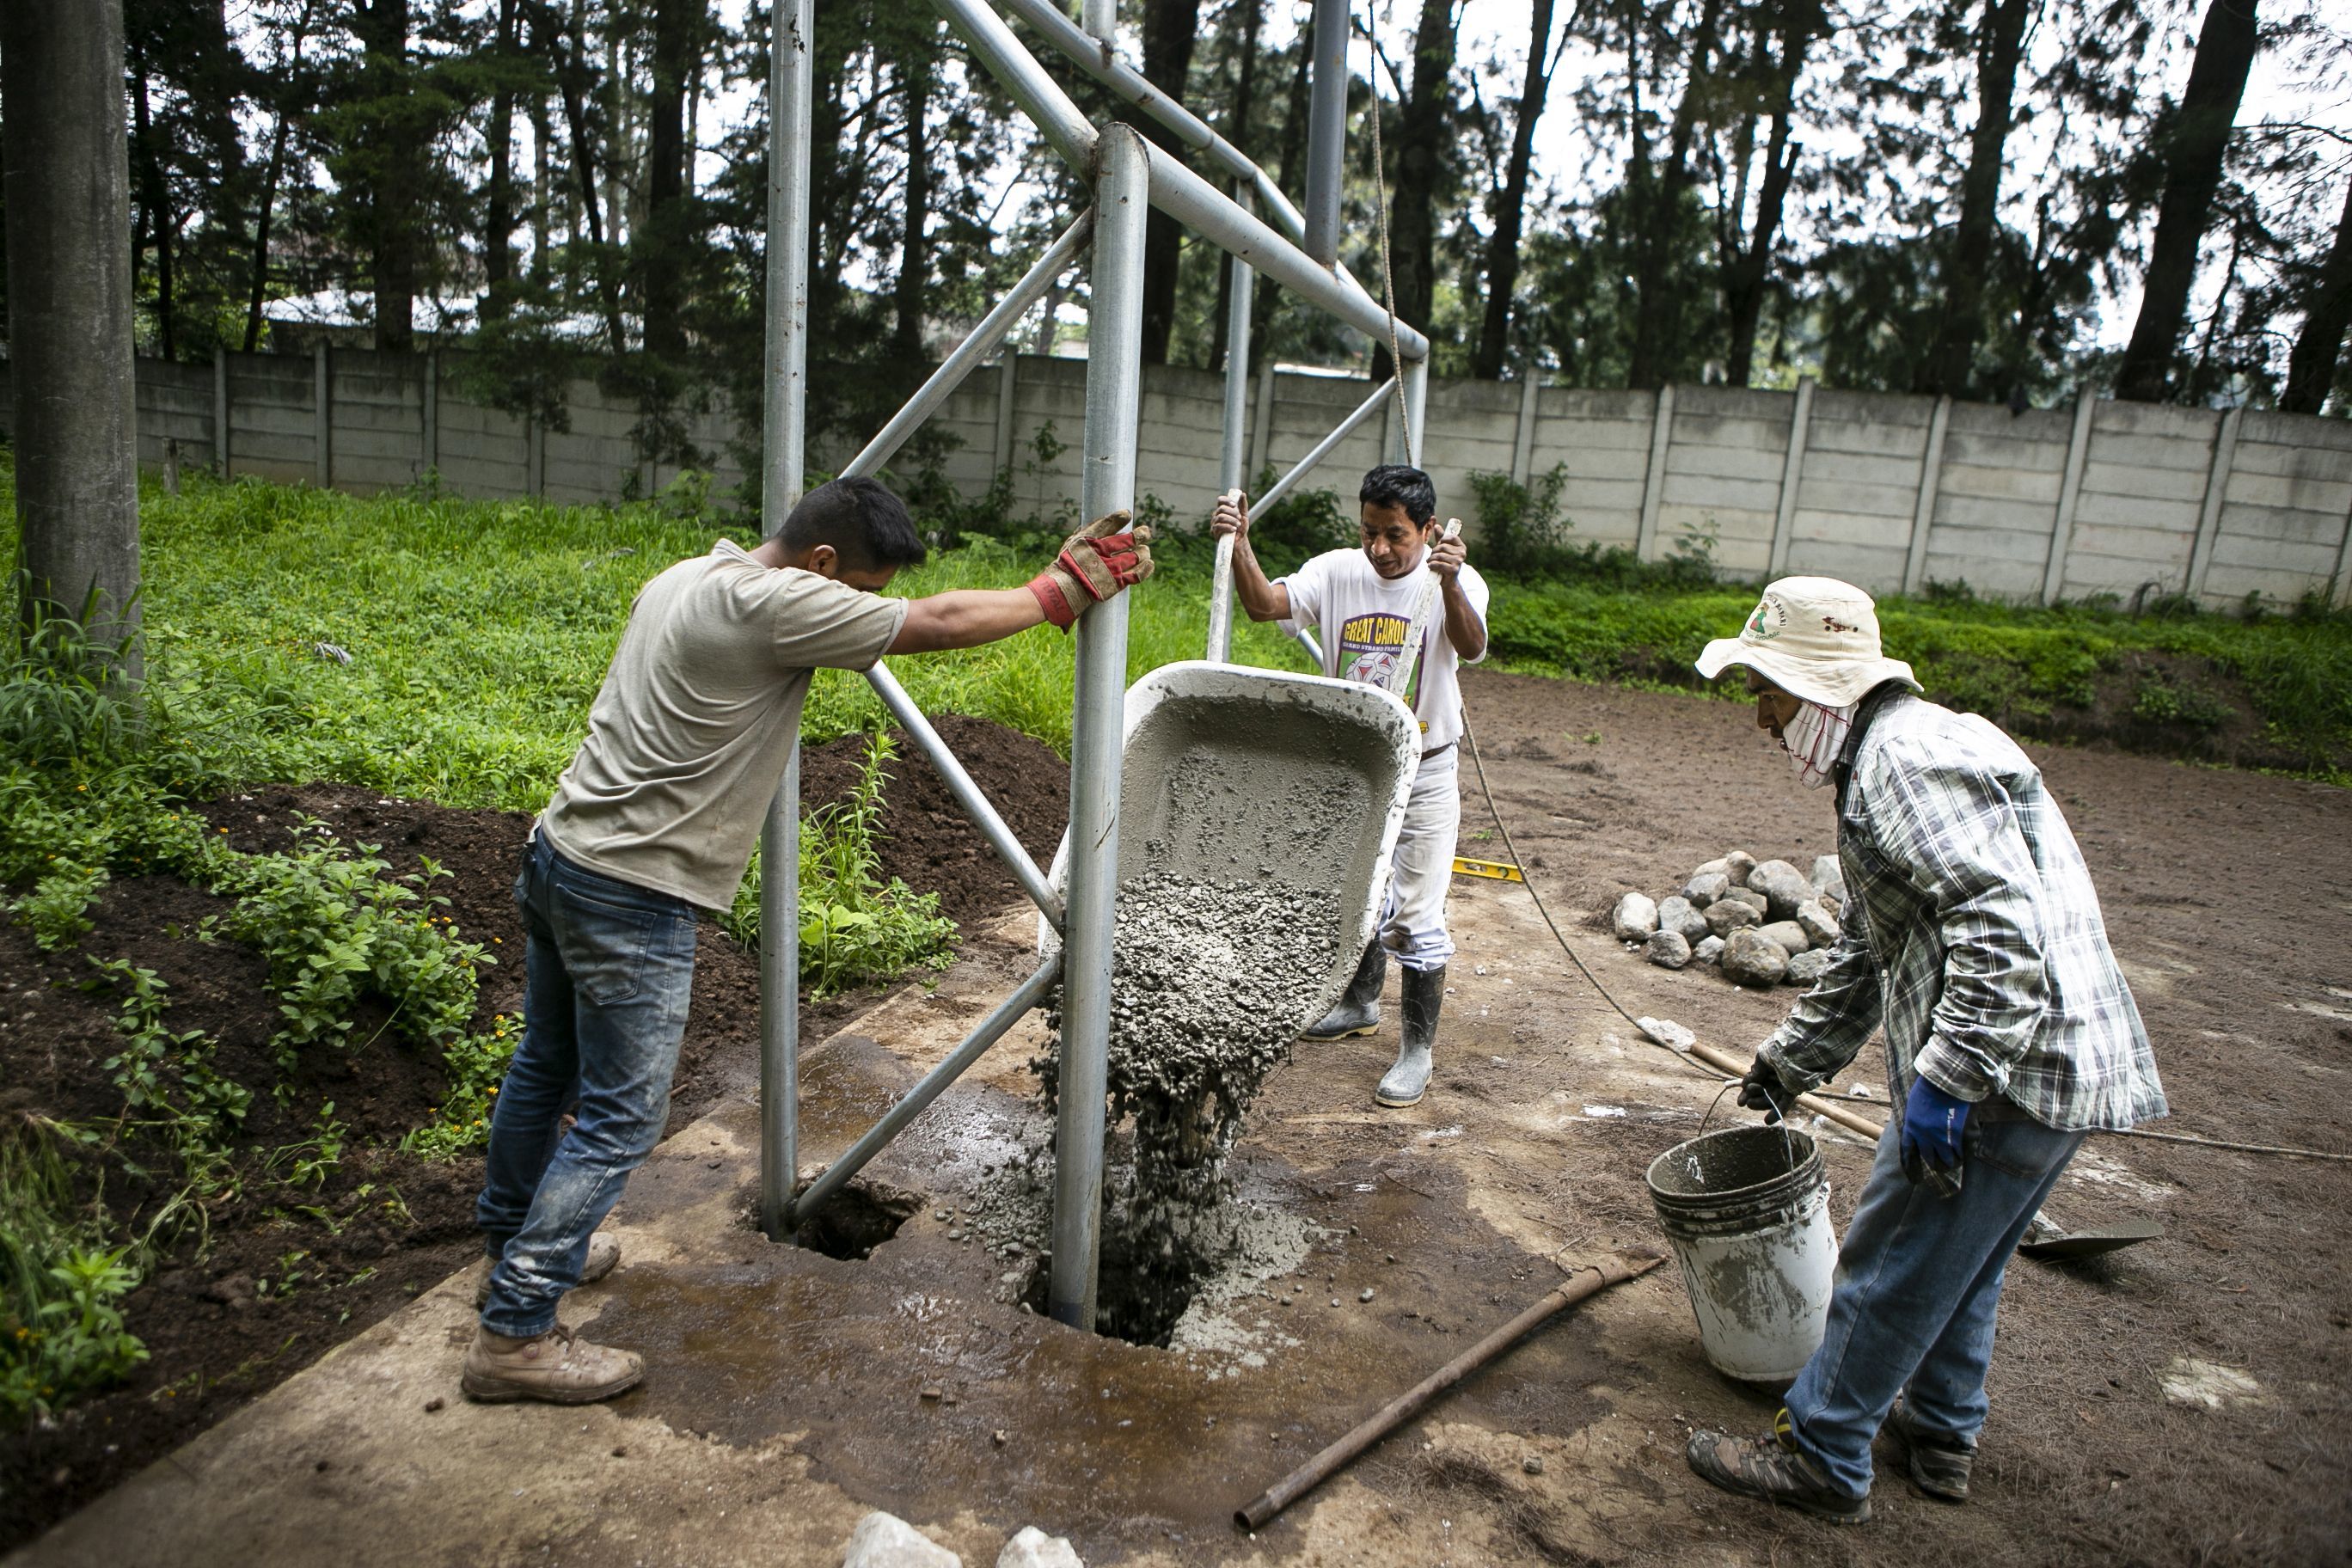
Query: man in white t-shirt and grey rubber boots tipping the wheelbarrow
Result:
<box><xmin>1209</xmin><ymin>463</ymin><xmax>1486</xmax><ymax>1105</ymax></box>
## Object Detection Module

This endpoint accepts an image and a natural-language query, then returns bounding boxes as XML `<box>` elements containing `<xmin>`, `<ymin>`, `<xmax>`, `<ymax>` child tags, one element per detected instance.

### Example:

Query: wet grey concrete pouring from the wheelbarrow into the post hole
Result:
<box><xmin>978</xmin><ymin>870</ymin><xmax>1338</xmax><ymax>1344</ymax></box>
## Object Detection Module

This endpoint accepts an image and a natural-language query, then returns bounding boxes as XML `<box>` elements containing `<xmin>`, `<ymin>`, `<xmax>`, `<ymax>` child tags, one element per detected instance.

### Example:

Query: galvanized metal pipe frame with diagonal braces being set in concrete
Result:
<box><xmin>760</xmin><ymin>0</ymin><xmax>1428</xmax><ymax>1328</ymax></box>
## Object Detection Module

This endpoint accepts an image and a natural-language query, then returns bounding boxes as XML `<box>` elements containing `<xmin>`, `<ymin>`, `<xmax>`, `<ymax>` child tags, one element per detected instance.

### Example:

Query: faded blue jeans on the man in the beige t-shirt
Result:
<box><xmin>475</xmin><ymin>835</ymin><xmax>694</xmax><ymax>1338</ymax></box>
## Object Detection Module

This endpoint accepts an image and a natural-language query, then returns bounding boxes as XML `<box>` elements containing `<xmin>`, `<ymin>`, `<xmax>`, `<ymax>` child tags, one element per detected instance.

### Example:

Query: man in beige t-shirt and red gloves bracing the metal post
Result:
<box><xmin>463</xmin><ymin>480</ymin><xmax>1153</xmax><ymax>1404</ymax></box>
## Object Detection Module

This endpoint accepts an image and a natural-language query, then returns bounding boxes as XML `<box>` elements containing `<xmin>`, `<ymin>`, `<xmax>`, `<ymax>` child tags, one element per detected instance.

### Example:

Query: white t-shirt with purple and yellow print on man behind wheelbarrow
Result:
<box><xmin>1275</xmin><ymin>550</ymin><xmax>1486</xmax><ymax>752</ymax></box>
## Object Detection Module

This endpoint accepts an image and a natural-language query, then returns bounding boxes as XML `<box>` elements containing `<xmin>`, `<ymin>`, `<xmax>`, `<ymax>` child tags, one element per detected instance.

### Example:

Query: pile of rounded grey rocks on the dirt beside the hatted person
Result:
<box><xmin>1608</xmin><ymin>848</ymin><xmax>1847</xmax><ymax>985</ymax></box>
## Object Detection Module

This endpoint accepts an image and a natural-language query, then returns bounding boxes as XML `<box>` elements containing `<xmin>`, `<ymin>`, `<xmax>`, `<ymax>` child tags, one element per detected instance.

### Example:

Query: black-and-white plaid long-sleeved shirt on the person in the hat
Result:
<box><xmin>1761</xmin><ymin>687</ymin><xmax>2166</xmax><ymax>1130</ymax></box>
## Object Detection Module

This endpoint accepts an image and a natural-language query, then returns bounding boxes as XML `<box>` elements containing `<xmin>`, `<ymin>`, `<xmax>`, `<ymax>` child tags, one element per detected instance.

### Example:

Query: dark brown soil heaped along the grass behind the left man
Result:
<box><xmin>0</xmin><ymin>717</ymin><xmax>1068</xmax><ymax>1552</ymax></box>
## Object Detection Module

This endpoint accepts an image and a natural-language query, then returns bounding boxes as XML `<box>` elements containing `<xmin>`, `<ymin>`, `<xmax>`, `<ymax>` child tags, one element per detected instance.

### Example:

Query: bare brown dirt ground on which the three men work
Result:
<box><xmin>7</xmin><ymin>675</ymin><xmax>2352</xmax><ymax>1565</ymax></box>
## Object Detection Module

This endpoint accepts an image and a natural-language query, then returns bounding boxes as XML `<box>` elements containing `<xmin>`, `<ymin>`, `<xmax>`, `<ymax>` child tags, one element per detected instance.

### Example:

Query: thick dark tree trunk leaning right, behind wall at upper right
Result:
<box><xmin>2115</xmin><ymin>0</ymin><xmax>2260</xmax><ymax>402</ymax></box>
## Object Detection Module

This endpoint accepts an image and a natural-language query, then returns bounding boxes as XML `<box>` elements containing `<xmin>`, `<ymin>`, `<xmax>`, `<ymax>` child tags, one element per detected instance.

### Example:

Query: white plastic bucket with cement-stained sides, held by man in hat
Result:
<box><xmin>1649</xmin><ymin>1126</ymin><xmax>1837</xmax><ymax>1385</ymax></box>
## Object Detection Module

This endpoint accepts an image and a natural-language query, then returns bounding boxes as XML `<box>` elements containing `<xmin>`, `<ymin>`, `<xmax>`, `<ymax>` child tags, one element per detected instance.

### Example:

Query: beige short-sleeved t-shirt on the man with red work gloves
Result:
<box><xmin>539</xmin><ymin>538</ymin><xmax>905</xmax><ymax>910</ymax></box>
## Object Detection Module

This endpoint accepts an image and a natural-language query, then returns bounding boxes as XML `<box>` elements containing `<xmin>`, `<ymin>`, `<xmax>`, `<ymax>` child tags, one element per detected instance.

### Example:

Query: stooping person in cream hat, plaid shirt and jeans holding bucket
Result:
<box><xmin>1688</xmin><ymin>579</ymin><xmax>2166</xmax><ymax>1523</ymax></box>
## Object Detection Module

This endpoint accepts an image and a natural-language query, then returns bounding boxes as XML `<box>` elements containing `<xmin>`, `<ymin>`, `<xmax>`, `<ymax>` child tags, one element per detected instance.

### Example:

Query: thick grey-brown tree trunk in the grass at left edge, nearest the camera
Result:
<box><xmin>0</xmin><ymin>0</ymin><xmax>138</xmax><ymax>682</ymax></box>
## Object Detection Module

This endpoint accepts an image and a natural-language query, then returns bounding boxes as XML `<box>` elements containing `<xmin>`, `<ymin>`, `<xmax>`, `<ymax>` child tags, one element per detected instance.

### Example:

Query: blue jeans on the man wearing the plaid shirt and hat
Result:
<box><xmin>1787</xmin><ymin>1107</ymin><xmax>2081</xmax><ymax>1498</ymax></box>
